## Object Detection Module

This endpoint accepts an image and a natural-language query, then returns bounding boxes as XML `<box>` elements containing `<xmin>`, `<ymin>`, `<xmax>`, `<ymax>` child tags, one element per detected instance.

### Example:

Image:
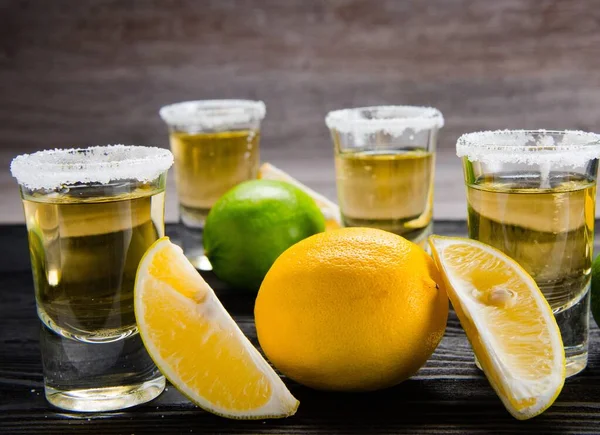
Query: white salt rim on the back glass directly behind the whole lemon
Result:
<box><xmin>325</xmin><ymin>106</ymin><xmax>444</xmax><ymax>136</ymax></box>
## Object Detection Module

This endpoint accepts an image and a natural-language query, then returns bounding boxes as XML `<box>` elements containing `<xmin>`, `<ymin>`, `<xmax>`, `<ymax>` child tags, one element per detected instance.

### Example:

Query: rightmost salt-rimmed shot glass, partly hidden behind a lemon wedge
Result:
<box><xmin>456</xmin><ymin>130</ymin><xmax>600</xmax><ymax>376</ymax></box>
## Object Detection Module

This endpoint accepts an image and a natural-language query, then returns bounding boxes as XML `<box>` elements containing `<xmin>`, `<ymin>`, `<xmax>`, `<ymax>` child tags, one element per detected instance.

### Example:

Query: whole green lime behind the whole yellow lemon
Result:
<box><xmin>204</xmin><ymin>180</ymin><xmax>325</xmax><ymax>291</ymax></box>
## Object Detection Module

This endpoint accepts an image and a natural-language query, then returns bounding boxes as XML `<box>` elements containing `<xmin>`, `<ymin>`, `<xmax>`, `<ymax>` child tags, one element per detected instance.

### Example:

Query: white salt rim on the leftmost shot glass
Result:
<box><xmin>10</xmin><ymin>145</ymin><xmax>173</xmax><ymax>190</ymax></box>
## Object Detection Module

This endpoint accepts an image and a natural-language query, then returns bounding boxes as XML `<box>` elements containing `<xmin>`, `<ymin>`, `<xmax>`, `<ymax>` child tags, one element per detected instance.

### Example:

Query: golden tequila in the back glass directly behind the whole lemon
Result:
<box><xmin>335</xmin><ymin>148</ymin><xmax>434</xmax><ymax>238</ymax></box>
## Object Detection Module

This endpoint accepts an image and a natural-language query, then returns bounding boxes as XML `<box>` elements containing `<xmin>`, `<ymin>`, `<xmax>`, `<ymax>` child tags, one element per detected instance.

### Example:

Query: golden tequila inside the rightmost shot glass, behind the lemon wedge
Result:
<box><xmin>467</xmin><ymin>172</ymin><xmax>596</xmax><ymax>314</ymax></box>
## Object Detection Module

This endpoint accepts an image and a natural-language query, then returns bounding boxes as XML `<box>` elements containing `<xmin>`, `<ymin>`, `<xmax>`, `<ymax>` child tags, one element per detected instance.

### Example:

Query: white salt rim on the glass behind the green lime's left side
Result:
<box><xmin>158</xmin><ymin>100</ymin><xmax>266</xmax><ymax>129</ymax></box>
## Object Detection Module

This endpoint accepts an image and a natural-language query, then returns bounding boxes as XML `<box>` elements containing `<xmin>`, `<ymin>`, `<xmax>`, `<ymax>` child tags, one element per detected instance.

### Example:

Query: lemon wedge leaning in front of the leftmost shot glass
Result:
<box><xmin>134</xmin><ymin>237</ymin><xmax>298</xmax><ymax>419</ymax></box>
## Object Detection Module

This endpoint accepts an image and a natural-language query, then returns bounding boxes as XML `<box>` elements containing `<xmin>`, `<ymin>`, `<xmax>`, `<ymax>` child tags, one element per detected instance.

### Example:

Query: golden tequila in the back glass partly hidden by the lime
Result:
<box><xmin>170</xmin><ymin>130</ymin><xmax>260</xmax><ymax>227</ymax></box>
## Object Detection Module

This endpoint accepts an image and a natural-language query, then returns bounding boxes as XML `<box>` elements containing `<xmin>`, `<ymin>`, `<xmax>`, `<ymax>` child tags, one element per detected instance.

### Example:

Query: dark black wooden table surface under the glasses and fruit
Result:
<box><xmin>0</xmin><ymin>221</ymin><xmax>600</xmax><ymax>435</ymax></box>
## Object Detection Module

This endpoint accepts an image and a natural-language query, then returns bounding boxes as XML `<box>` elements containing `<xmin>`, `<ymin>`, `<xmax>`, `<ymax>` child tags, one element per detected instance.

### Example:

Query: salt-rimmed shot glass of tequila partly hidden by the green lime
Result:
<box><xmin>159</xmin><ymin>100</ymin><xmax>266</xmax><ymax>270</ymax></box>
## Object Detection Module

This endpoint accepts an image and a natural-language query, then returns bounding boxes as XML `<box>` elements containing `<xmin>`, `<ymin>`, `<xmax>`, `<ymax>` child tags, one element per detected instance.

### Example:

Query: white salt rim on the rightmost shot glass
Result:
<box><xmin>456</xmin><ymin>129</ymin><xmax>600</xmax><ymax>167</ymax></box>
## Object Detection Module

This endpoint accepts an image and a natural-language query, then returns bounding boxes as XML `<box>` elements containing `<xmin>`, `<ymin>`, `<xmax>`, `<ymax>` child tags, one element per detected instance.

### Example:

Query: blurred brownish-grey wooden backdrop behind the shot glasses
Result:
<box><xmin>0</xmin><ymin>0</ymin><xmax>600</xmax><ymax>222</ymax></box>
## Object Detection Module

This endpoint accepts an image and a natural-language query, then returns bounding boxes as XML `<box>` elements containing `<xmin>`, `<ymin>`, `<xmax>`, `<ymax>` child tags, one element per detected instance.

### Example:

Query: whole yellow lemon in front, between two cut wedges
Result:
<box><xmin>254</xmin><ymin>228</ymin><xmax>448</xmax><ymax>391</ymax></box>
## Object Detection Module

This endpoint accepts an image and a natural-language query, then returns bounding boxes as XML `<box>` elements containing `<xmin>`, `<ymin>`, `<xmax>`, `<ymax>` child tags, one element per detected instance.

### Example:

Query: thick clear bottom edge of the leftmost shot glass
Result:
<box><xmin>46</xmin><ymin>376</ymin><xmax>165</xmax><ymax>412</ymax></box>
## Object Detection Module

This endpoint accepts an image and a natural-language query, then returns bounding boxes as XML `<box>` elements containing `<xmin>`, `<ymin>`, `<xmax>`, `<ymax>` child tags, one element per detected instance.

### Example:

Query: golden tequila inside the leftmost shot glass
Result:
<box><xmin>23</xmin><ymin>185</ymin><xmax>165</xmax><ymax>342</ymax></box>
